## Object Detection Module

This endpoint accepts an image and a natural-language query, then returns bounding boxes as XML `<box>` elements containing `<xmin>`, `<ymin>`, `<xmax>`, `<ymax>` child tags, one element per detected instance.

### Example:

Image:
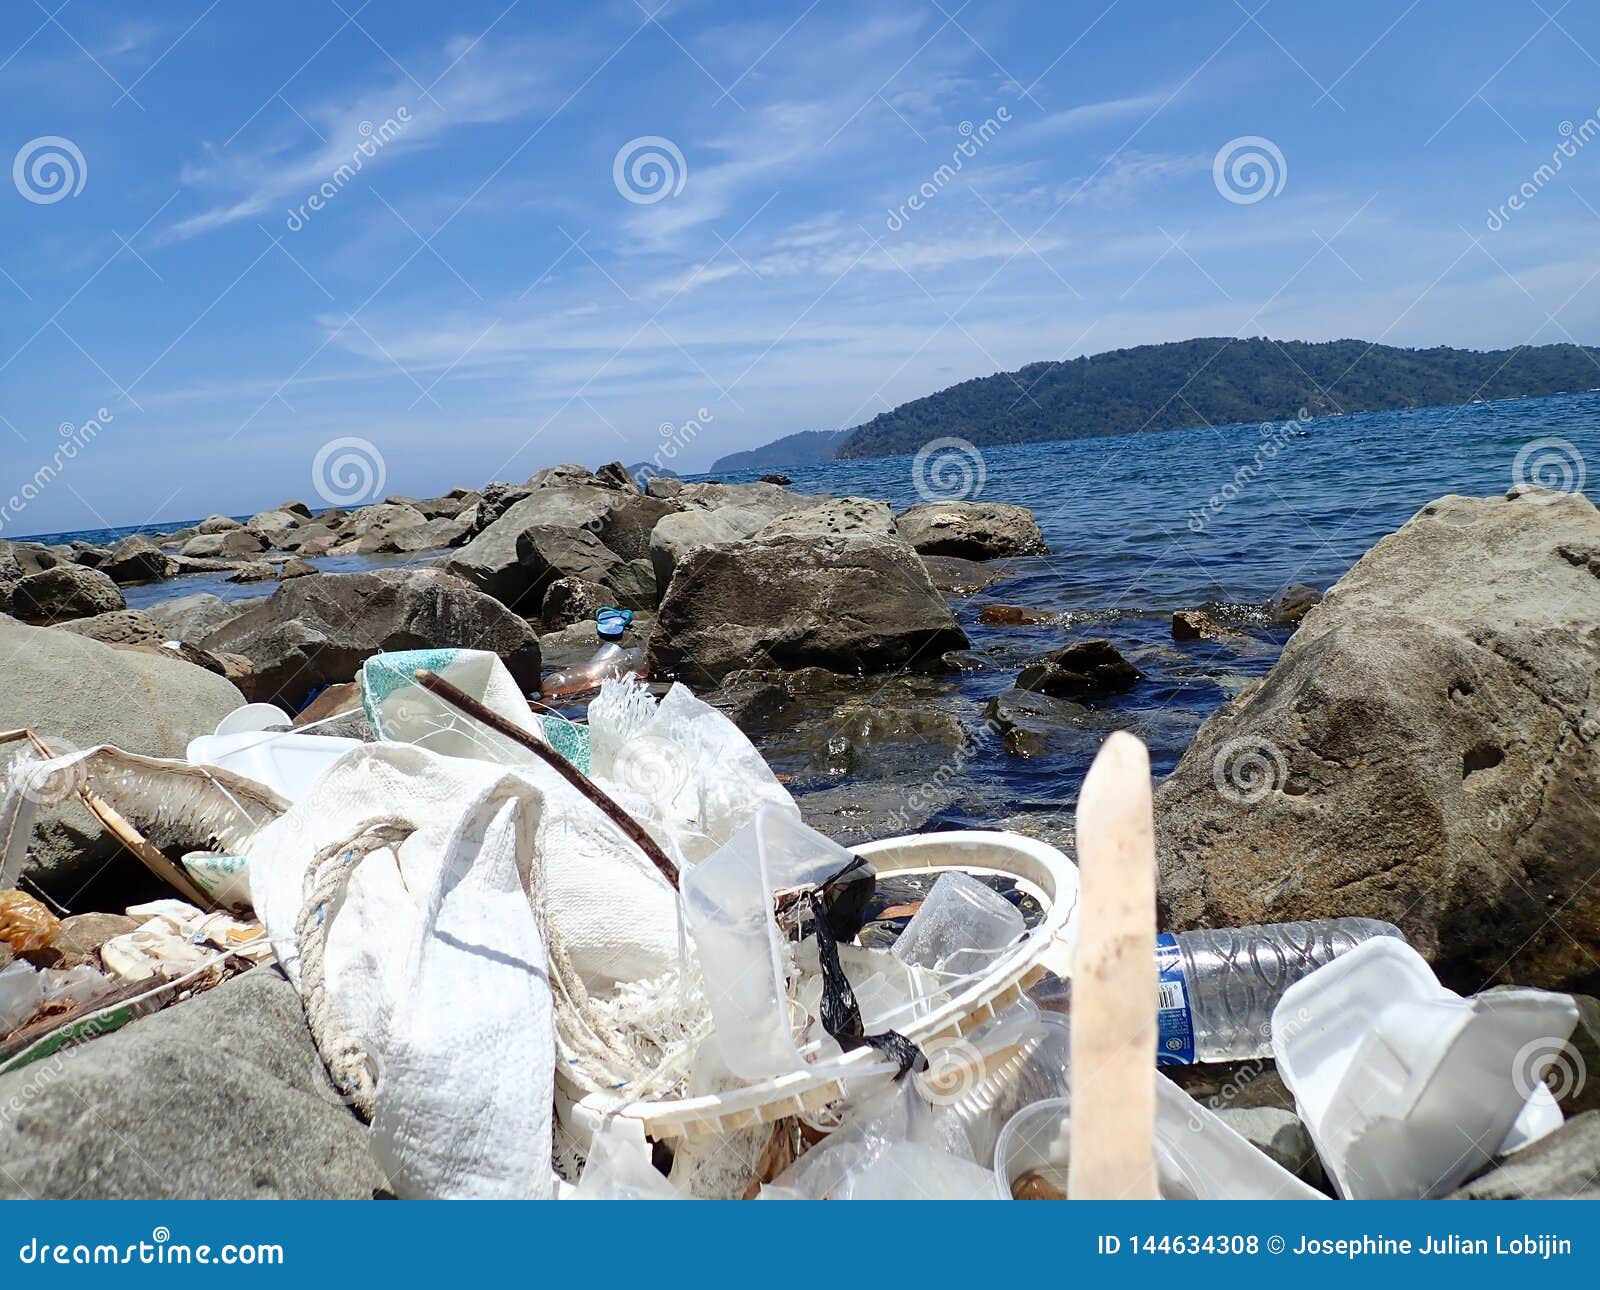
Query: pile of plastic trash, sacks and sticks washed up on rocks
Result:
<box><xmin>0</xmin><ymin>629</ymin><xmax>1578</xmax><ymax>1199</ymax></box>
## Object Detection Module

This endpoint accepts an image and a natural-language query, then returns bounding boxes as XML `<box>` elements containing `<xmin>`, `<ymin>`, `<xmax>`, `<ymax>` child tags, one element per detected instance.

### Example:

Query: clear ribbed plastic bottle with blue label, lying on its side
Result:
<box><xmin>1155</xmin><ymin>919</ymin><xmax>1403</xmax><ymax>1066</ymax></box>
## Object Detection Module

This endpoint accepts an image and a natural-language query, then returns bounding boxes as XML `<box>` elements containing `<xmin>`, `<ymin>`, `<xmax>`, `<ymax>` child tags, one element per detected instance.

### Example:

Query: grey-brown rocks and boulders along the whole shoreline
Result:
<box><xmin>0</xmin><ymin>464</ymin><xmax>1600</xmax><ymax>1196</ymax></box>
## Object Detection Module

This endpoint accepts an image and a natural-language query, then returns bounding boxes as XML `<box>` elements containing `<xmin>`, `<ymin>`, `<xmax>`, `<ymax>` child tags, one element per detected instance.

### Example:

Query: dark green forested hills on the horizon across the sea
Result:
<box><xmin>718</xmin><ymin>336</ymin><xmax>1600</xmax><ymax>466</ymax></box>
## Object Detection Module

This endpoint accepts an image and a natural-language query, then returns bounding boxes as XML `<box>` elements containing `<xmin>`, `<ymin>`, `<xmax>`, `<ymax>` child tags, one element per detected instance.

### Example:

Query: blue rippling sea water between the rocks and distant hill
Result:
<box><xmin>18</xmin><ymin>392</ymin><xmax>1600</xmax><ymax>824</ymax></box>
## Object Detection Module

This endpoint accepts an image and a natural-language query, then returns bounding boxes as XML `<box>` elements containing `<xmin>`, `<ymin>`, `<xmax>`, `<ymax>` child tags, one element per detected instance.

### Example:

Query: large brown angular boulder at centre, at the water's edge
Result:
<box><xmin>650</xmin><ymin>535</ymin><xmax>968</xmax><ymax>687</ymax></box>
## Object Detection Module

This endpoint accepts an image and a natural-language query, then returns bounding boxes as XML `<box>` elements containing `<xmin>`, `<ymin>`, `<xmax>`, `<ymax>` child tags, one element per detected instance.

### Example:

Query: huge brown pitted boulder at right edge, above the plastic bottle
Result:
<box><xmin>1157</xmin><ymin>491</ymin><xmax>1600</xmax><ymax>992</ymax></box>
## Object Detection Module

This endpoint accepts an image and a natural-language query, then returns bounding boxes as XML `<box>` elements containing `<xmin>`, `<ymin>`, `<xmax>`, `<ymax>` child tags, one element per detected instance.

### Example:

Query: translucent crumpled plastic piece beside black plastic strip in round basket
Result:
<box><xmin>682</xmin><ymin>807</ymin><xmax>854</xmax><ymax>1079</ymax></box>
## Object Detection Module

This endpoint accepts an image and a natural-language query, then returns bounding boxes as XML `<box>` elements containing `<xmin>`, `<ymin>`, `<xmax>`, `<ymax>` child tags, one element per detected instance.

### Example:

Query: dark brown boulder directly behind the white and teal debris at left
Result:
<box><xmin>197</xmin><ymin>568</ymin><xmax>539</xmax><ymax>711</ymax></box>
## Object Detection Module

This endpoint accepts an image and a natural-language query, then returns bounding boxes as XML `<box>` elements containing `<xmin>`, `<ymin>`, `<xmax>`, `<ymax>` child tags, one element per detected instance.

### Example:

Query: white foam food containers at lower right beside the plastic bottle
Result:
<box><xmin>1272</xmin><ymin>936</ymin><xmax>1578</xmax><ymax>1200</ymax></box>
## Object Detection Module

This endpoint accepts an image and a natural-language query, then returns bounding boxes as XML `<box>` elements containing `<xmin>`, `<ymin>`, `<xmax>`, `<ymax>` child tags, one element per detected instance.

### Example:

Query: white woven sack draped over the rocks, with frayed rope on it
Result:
<box><xmin>250</xmin><ymin>744</ymin><xmax>555</xmax><ymax>1199</ymax></box>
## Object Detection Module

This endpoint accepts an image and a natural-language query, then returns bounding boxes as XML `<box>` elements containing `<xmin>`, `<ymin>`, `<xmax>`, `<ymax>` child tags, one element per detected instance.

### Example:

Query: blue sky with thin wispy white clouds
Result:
<box><xmin>0</xmin><ymin>0</ymin><xmax>1600</xmax><ymax>536</ymax></box>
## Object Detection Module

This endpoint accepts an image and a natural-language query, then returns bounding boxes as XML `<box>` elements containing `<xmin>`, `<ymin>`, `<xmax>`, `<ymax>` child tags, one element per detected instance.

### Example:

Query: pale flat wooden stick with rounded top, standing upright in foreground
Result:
<box><xmin>1067</xmin><ymin>731</ymin><xmax>1160</xmax><ymax>1200</ymax></box>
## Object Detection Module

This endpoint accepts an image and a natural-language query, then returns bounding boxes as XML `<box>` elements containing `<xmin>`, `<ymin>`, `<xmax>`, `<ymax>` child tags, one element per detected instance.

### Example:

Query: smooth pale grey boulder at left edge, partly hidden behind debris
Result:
<box><xmin>0</xmin><ymin>618</ymin><xmax>245</xmax><ymax>904</ymax></box>
